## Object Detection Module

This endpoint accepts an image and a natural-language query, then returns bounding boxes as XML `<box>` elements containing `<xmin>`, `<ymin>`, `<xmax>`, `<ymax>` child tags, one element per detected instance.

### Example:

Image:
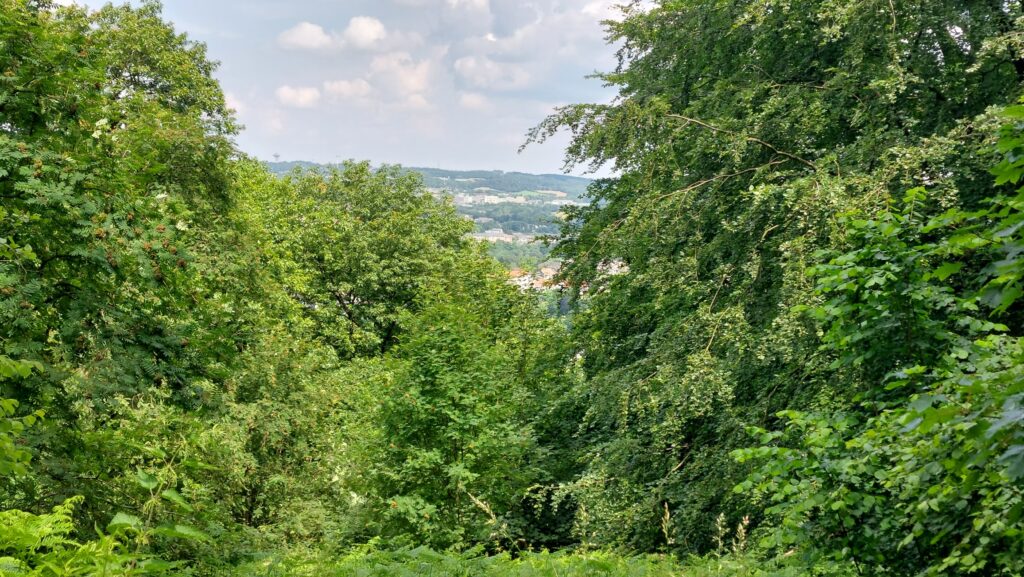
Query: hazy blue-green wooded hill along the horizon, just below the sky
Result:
<box><xmin>266</xmin><ymin>161</ymin><xmax>592</xmax><ymax>199</ymax></box>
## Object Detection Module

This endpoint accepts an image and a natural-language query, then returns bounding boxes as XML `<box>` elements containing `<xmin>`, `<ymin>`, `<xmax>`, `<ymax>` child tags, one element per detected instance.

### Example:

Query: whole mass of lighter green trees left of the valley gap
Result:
<box><xmin>0</xmin><ymin>0</ymin><xmax>577</xmax><ymax>575</ymax></box>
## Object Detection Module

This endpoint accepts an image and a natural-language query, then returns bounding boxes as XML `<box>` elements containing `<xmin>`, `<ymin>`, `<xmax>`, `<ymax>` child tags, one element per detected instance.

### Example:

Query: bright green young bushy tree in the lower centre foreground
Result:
<box><xmin>368</xmin><ymin>305</ymin><xmax>534</xmax><ymax>546</ymax></box>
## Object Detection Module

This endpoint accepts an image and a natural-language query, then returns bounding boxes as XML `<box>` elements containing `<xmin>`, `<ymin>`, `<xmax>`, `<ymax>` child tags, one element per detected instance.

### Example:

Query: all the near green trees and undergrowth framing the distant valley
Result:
<box><xmin>0</xmin><ymin>0</ymin><xmax>1024</xmax><ymax>577</ymax></box>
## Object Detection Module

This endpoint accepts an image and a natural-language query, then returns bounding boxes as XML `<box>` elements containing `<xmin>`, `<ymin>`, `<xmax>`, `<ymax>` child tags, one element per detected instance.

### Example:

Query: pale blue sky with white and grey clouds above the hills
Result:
<box><xmin>74</xmin><ymin>0</ymin><xmax>618</xmax><ymax>174</ymax></box>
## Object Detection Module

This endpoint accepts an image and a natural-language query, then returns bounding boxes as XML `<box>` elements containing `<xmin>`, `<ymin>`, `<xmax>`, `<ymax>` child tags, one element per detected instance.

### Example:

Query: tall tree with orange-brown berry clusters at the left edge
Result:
<box><xmin>0</xmin><ymin>1</ymin><xmax>232</xmax><ymax>418</ymax></box>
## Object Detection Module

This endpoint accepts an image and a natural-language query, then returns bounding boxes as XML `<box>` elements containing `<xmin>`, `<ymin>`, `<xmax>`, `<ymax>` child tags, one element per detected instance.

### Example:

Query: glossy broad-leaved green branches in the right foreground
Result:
<box><xmin>737</xmin><ymin>109</ymin><xmax>1024</xmax><ymax>575</ymax></box>
